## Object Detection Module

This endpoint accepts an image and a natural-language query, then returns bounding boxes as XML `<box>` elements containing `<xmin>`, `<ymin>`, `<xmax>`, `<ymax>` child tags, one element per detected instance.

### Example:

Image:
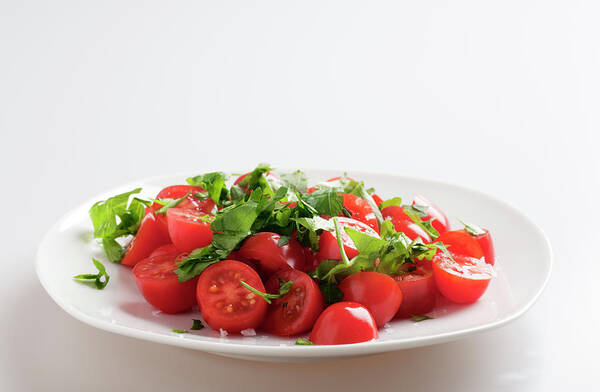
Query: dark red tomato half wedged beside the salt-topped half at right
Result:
<box><xmin>394</xmin><ymin>267</ymin><xmax>437</xmax><ymax>318</ymax></box>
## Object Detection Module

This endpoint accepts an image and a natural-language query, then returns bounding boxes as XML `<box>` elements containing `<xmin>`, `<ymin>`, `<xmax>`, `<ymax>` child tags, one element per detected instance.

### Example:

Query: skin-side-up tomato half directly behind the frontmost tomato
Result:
<box><xmin>338</xmin><ymin>272</ymin><xmax>402</xmax><ymax>327</ymax></box>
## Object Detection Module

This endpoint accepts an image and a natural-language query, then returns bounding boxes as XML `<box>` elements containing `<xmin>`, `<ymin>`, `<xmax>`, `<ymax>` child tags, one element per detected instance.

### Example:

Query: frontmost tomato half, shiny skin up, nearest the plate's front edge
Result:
<box><xmin>310</xmin><ymin>301</ymin><xmax>379</xmax><ymax>345</ymax></box>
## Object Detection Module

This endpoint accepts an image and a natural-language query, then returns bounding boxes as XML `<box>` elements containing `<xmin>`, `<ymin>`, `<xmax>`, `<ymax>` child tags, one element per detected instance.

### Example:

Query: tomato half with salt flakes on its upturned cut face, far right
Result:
<box><xmin>433</xmin><ymin>253</ymin><xmax>495</xmax><ymax>304</ymax></box>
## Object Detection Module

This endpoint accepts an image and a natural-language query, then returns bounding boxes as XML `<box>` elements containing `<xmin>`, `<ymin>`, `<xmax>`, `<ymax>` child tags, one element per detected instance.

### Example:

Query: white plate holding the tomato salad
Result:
<box><xmin>37</xmin><ymin>170</ymin><xmax>552</xmax><ymax>361</ymax></box>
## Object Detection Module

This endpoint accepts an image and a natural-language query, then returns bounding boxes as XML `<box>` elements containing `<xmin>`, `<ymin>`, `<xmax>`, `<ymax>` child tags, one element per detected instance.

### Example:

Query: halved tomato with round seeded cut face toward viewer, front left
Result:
<box><xmin>196</xmin><ymin>260</ymin><xmax>267</xmax><ymax>333</ymax></box>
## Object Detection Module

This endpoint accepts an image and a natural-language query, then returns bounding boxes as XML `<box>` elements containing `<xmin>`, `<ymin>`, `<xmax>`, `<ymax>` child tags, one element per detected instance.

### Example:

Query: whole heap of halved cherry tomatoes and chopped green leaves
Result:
<box><xmin>75</xmin><ymin>164</ymin><xmax>495</xmax><ymax>345</ymax></box>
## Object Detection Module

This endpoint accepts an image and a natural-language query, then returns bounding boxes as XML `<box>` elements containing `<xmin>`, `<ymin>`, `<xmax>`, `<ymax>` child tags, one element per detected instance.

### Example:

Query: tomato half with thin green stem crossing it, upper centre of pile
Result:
<box><xmin>317</xmin><ymin>217</ymin><xmax>381</xmax><ymax>262</ymax></box>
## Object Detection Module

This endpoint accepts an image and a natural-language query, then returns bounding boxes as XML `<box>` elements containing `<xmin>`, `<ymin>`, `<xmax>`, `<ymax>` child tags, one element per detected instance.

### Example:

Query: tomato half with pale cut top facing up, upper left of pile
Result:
<box><xmin>167</xmin><ymin>208</ymin><xmax>213</xmax><ymax>252</ymax></box>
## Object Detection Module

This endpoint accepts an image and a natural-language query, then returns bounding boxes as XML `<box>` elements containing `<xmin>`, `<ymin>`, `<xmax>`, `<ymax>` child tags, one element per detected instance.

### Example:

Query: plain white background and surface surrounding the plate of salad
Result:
<box><xmin>0</xmin><ymin>0</ymin><xmax>600</xmax><ymax>392</ymax></box>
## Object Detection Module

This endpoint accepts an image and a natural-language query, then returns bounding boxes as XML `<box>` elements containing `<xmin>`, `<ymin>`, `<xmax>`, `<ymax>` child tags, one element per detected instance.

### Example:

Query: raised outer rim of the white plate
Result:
<box><xmin>35</xmin><ymin>168</ymin><xmax>554</xmax><ymax>359</ymax></box>
